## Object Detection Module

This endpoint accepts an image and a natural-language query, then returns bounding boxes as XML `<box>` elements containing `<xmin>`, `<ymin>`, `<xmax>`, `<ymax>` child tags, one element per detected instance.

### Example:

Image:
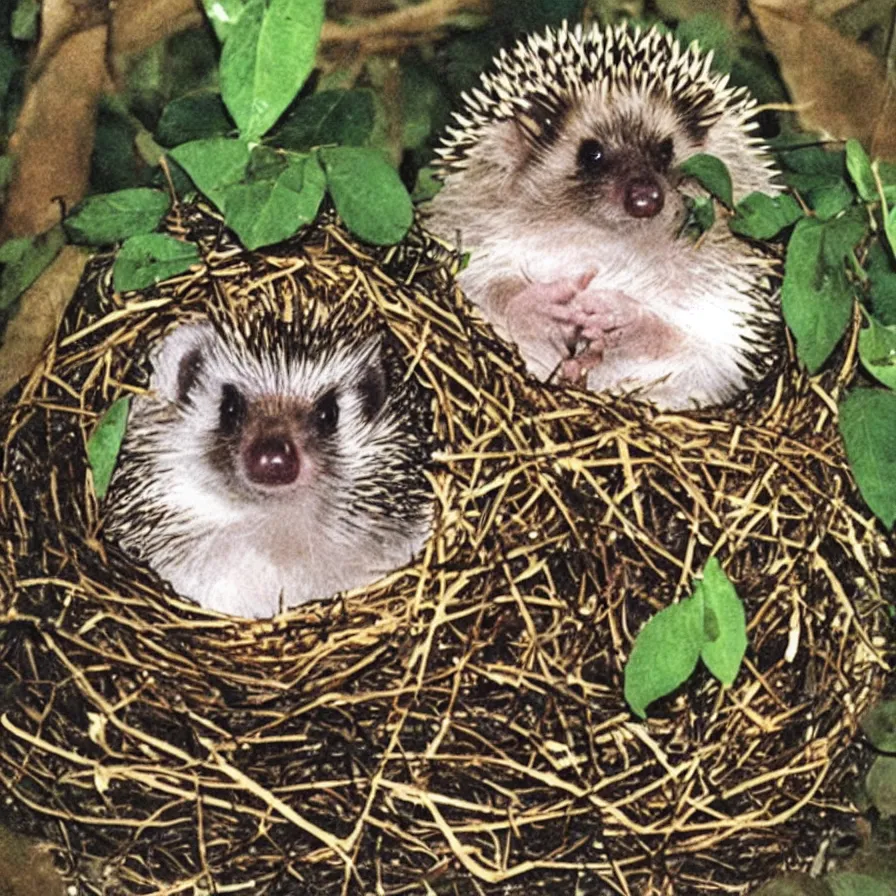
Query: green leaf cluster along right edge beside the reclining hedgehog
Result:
<box><xmin>682</xmin><ymin>138</ymin><xmax>896</xmax><ymax>529</ymax></box>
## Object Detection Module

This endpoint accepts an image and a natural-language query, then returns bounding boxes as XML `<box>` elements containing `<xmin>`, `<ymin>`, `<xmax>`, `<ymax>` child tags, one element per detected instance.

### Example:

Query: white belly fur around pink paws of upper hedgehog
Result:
<box><xmin>458</xmin><ymin>226</ymin><xmax>761</xmax><ymax>408</ymax></box>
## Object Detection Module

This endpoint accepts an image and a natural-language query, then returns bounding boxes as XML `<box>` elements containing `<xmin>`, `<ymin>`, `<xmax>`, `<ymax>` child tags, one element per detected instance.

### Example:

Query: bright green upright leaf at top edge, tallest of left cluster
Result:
<box><xmin>221</xmin><ymin>0</ymin><xmax>324</xmax><ymax>140</ymax></box>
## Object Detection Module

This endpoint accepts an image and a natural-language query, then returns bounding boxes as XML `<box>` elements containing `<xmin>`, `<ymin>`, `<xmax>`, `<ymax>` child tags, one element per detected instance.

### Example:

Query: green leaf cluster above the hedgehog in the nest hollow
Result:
<box><xmin>66</xmin><ymin>0</ymin><xmax>413</xmax><ymax>290</ymax></box>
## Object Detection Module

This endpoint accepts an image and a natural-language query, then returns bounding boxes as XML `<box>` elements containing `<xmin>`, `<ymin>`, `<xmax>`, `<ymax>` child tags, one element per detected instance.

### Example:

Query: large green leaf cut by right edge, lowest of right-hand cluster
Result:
<box><xmin>840</xmin><ymin>389</ymin><xmax>896</xmax><ymax>529</ymax></box>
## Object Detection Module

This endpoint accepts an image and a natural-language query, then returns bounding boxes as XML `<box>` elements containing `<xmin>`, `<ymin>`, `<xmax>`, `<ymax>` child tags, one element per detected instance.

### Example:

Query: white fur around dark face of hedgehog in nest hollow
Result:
<box><xmin>108</xmin><ymin>324</ymin><xmax>429</xmax><ymax>617</ymax></box>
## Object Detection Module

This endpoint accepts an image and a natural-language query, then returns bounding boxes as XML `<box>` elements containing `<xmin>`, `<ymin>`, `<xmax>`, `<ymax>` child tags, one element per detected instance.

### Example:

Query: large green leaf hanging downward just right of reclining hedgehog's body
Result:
<box><xmin>781</xmin><ymin>218</ymin><xmax>853</xmax><ymax>373</ymax></box>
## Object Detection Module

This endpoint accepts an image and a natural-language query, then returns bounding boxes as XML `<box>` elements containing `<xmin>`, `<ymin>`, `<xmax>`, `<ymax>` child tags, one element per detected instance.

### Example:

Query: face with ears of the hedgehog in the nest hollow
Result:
<box><xmin>153</xmin><ymin>325</ymin><xmax>387</xmax><ymax>502</ymax></box>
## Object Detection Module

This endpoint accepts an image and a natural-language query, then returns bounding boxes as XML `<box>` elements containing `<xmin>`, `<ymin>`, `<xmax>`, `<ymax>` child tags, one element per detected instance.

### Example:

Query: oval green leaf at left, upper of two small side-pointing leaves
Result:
<box><xmin>64</xmin><ymin>187</ymin><xmax>170</xmax><ymax>246</ymax></box>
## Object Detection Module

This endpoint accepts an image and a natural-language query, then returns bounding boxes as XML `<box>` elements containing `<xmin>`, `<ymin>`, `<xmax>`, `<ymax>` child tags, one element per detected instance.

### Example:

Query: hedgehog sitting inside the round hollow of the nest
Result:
<box><xmin>104</xmin><ymin>320</ymin><xmax>433</xmax><ymax>617</ymax></box>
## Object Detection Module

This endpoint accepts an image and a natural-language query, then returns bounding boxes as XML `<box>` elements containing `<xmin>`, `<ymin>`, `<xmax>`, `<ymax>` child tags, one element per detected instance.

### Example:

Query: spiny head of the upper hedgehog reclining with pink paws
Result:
<box><xmin>430</xmin><ymin>24</ymin><xmax>775</xmax><ymax>247</ymax></box>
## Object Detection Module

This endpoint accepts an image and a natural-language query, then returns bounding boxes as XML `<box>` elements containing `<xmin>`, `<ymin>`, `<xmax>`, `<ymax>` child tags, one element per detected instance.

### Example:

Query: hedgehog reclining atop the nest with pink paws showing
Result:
<box><xmin>425</xmin><ymin>23</ymin><xmax>783</xmax><ymax>410</ymax></box>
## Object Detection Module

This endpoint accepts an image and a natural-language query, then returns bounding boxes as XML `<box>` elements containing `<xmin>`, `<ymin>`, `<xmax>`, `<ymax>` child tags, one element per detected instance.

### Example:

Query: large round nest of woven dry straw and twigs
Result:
<box><xmin>0</xmin><ymin>210</ymin><xmax>896</xmax><ymax>894</ymax></box>
